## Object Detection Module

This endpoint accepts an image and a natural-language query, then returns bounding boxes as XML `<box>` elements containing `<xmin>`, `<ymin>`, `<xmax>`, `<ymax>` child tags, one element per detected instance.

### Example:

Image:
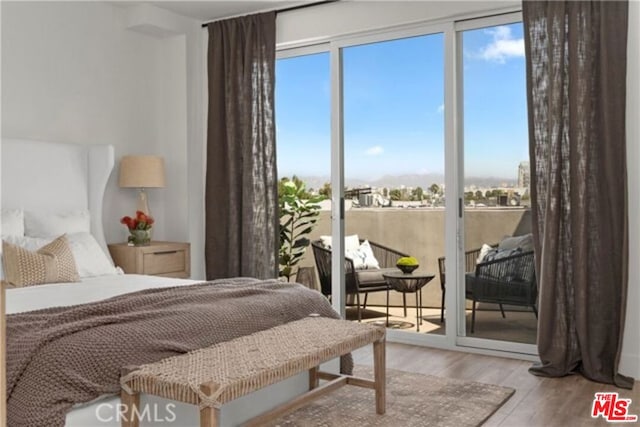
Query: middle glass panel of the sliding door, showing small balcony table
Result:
<box><xmin>342</xmin><ymin>32</ymin><xmax>445</xmax><ymax>335</ymax></box>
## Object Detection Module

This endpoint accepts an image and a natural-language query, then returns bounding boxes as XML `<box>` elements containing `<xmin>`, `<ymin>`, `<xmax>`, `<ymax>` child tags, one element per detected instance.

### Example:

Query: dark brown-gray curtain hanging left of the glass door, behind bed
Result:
<box><xmin>205</xmin><ymin>12</ymin><xmax>279</xmax><ymax>280</ymax></box>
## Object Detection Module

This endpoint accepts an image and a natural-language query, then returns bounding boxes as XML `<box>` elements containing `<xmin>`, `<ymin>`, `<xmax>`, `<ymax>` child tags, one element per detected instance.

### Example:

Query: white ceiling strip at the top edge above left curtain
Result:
<box><xmin>118</xmin><ymin>0</ymin><xmax>317</xmax><ymax>22</ymax></box>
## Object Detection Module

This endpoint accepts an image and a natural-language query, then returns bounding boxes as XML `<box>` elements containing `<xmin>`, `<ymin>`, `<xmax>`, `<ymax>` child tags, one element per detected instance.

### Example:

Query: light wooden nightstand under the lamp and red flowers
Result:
<box><xmin>109</xmin><ymin>242</ymin><xmax>191</xmax><ymax>279</ymax></box>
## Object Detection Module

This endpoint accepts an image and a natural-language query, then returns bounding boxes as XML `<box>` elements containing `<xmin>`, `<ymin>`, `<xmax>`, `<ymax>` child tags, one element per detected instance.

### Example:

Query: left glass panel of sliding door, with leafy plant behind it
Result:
<box><xmin>275</xmin><ymin>47</ymin><xmax>331</xmax><ymax>296</ymax></box>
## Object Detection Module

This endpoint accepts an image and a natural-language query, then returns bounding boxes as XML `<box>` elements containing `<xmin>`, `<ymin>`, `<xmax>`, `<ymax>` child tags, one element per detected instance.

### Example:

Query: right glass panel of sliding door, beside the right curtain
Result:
<box><xmin>457</xmin><ymin>15</ymin><xmax>537</xmax><ymax>353</ymax></box>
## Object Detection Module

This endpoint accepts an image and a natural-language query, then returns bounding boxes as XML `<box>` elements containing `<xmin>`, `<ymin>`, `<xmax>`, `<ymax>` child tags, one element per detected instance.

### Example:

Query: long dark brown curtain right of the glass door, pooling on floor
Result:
<box><xmin>523</xmin><ymin>1</ymin><xmax>633</xmax><ymax>388</ymax></box>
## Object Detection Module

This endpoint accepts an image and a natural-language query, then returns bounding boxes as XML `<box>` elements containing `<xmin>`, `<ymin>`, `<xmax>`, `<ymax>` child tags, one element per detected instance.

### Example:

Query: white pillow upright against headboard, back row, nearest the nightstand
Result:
<box><xmin>24</xmin><ymin>209</ymin><xmax>91</xmax><ymax>237</ymax></box>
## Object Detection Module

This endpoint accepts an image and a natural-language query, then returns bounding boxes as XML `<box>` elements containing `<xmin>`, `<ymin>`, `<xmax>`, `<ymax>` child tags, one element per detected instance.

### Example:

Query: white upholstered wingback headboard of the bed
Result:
<box><xmin>0</xmin><ymin>139</ymin><xmax>114</xmax><ymax>258</ymax></box>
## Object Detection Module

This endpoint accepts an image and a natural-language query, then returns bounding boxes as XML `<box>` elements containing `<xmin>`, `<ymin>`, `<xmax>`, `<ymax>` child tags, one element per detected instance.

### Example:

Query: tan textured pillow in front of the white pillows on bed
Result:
<box><xmin>2</xmin><ymin>235</ymin><xmax>80</xmax><ymax>286</ymax></box>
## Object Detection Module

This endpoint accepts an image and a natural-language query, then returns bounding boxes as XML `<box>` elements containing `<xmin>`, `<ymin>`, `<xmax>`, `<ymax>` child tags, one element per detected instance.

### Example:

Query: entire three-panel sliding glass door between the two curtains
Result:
<box><xmin>276</xmin><ymin>13</ymin><xmax>537</xmax><ymax>354</ymax></box>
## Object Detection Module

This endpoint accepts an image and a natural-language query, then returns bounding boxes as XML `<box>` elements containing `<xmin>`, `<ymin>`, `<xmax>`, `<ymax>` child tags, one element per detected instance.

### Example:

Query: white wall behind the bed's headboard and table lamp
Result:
<box><xmin>2</xmin><ymin>2</ymin><xmax>159</xmax><ymax>242</ymax></box>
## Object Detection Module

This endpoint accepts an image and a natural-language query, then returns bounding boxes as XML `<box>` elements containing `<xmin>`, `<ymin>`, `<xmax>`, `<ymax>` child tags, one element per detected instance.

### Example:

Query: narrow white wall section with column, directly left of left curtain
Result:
<box><xmin>127</xmin><ymin>4</ymin><xmax>206</xmax><ymax>279</ymax></box>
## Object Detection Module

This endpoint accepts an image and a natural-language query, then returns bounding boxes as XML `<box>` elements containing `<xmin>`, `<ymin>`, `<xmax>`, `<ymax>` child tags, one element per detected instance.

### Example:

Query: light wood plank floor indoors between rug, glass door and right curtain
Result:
<box><xmin>353</xmin><ymin>343</ymin><xmax>640</xmax><ymax>427</ymax></box>
